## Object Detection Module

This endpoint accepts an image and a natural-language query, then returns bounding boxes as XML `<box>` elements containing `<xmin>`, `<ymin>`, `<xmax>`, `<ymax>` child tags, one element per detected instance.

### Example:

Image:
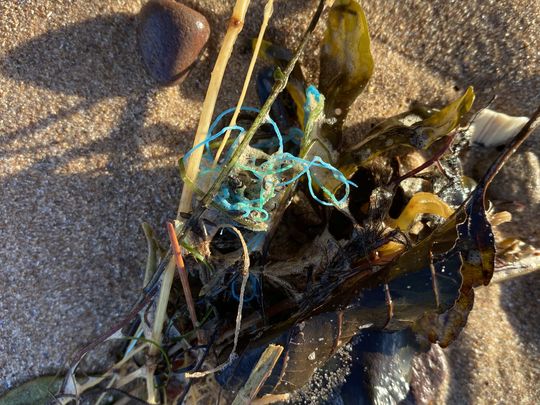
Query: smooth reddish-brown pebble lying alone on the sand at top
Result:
<box><xmin>137</xmin><ymin>0</ymin><xmax>210</xmax><ymax>86</ymax></box>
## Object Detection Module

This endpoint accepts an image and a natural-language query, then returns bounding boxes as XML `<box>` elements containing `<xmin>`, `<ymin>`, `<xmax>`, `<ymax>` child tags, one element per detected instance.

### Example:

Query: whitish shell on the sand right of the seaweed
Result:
<box><xmin>469</xmin><ymin>108</ymin><xmax>529</xmax><ymax>146</ymax></box>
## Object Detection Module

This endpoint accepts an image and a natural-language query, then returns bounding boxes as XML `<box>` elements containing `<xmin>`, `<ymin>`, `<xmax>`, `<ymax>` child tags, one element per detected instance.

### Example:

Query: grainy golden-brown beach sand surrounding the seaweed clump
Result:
<box><xmin>0</xmin><ymin>0</ymin><xmax>540</xmax><ymax>404</ymax></box>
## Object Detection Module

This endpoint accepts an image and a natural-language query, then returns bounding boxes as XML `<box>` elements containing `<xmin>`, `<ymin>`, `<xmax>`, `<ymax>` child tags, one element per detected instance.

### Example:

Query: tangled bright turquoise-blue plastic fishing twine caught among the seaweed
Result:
<box><xmin>182</xmin><ymin>98</ymin><xmax>356</xmax><ymax>223</ymax></box>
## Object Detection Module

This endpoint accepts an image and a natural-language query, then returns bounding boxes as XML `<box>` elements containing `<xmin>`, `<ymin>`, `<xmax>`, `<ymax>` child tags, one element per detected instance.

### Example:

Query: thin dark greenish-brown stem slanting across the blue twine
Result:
<box><xmin>144</xmin><ymin>0</ymin><xmax>325</xmax><ymax>293</ymax></box>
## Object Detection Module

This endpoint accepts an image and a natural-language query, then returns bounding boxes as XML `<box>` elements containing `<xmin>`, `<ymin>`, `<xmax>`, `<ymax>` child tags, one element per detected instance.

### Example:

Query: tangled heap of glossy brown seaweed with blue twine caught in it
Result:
<box><xmin>7</xmin><ymin>0</ymin><xmax>540</xmax><ymax>404</ymax></box>
